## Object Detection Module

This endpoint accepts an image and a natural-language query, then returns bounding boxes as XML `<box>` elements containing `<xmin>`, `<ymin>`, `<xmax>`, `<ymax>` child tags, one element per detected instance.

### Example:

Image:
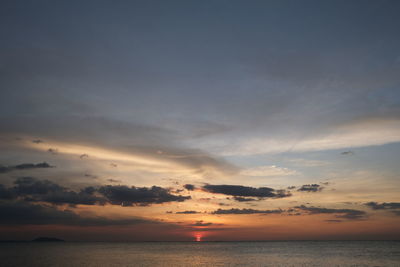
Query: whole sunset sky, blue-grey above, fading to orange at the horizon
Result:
<box><xmin>0</xmin><ymin>0</ymin><xmax>400</xmax><ymax>241</ymax></box>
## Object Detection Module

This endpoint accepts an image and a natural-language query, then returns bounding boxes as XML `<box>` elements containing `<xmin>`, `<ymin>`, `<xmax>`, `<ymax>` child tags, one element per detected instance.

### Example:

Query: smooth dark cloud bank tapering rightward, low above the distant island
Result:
<box><xmin>0</xmin><ymin>202</ymin><xmax>156</xmax><ymax>226</ymax></box>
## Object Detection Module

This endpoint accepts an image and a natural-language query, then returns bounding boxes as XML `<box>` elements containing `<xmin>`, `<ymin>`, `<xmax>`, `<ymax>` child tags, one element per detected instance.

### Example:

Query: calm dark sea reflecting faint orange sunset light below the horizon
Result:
<box><xmin>0</xmin><ymin>241</ymin><xmax>400</xmax><ymax>267</ymax></box>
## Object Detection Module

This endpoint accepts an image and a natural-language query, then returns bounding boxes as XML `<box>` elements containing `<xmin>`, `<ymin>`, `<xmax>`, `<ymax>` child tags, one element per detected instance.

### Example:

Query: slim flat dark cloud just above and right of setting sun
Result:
<box><xmin>203</xmin><ymin>184</ymin><xmax>291</xmax><ymax>198</ymax></box>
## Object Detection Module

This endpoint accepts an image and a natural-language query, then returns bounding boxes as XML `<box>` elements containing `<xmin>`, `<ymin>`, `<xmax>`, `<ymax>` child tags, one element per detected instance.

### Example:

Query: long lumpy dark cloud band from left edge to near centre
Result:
<box><xmin>0</xmin><ymin>177</ymin><xmax>190</xmax><ymax>206</ymax></box>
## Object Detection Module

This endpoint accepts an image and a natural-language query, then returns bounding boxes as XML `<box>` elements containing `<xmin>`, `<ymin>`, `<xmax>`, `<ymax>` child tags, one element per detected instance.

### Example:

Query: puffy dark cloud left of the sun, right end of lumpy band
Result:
<box><xmin>98</xmin><ymin>185</ymin><xmax>191</xmax><ymax>206</ymax></box>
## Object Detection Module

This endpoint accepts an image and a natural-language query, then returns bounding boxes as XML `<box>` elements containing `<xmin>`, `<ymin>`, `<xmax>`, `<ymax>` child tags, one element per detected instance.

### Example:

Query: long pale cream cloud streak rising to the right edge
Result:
<box><xmin>217</xmin><ymin>118</ymin><xmax>400</xmax><ymax>156</ymax></box>
